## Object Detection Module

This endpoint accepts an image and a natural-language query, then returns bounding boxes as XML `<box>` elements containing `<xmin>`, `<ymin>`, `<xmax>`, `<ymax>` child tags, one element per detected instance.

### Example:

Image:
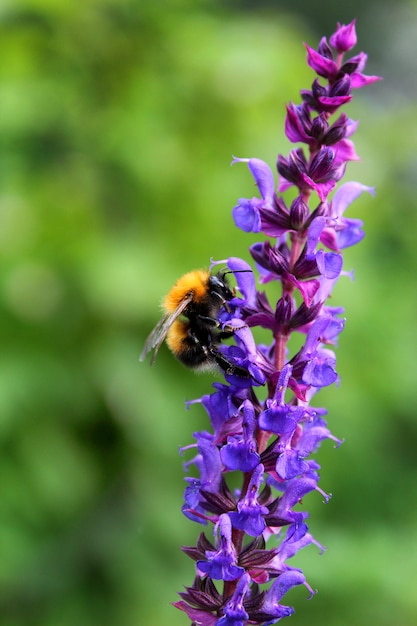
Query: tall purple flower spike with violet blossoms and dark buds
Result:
<box><xmin>175</xmin><ymin>22</ymin><xmax>378</xmax><ymax>626</ymax></box>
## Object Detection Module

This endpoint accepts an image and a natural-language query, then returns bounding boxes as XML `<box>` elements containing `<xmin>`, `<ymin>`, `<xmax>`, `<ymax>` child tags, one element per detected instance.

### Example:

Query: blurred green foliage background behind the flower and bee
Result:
<box><xmin>0</xmin><ymin>0</ymin><xmax>417</xmax><ymax>626</ymax></box>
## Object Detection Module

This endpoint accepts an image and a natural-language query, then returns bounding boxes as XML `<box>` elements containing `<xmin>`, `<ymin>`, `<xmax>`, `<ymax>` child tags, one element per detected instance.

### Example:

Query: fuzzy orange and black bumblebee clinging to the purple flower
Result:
<box><xmin>140</xmin><ymin>270</ymin><xmax>250</xmax><ymax>378</ymax></box>
